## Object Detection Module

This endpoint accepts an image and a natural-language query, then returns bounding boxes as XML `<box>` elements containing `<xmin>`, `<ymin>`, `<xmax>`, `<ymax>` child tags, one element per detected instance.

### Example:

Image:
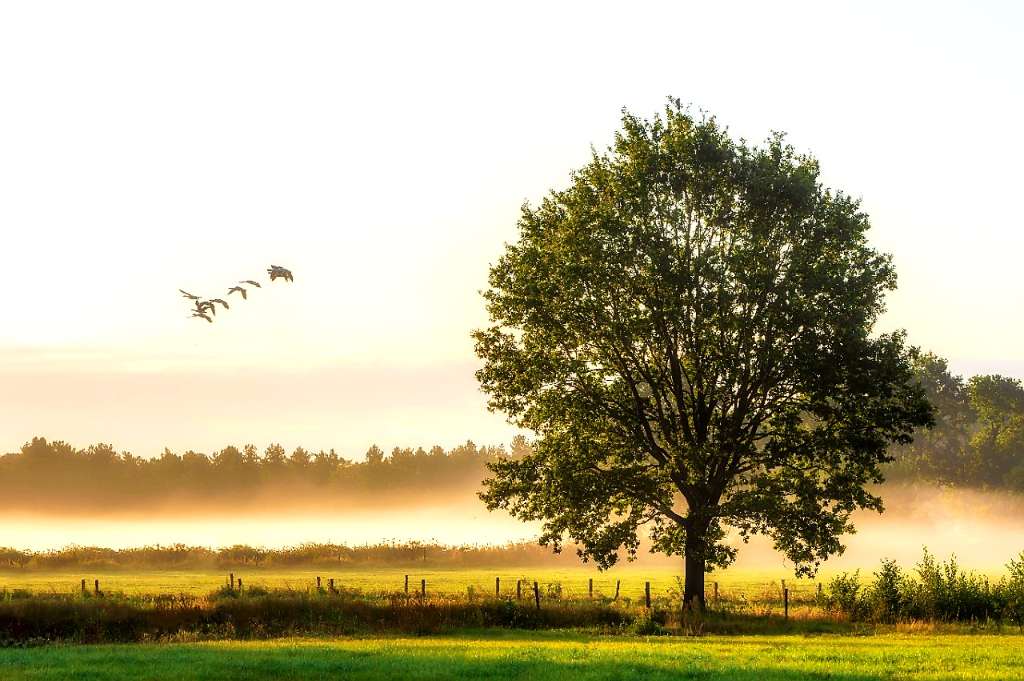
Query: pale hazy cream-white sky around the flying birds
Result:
<box><xmin>0</xmin><ymin>0</ymin><xmax>1024</xmax><ymax>457</ymax></box>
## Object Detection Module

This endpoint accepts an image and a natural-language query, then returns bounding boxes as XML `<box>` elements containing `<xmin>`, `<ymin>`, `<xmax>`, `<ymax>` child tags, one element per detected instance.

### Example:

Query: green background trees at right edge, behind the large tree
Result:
<box><xmin>887</xmin><ymin>354</ymin><xmax>1024</xmax><ymax>492</ymax></box>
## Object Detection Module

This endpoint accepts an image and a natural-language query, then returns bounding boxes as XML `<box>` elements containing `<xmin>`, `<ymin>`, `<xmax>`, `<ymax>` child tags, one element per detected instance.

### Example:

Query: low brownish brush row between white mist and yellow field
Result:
<box><xmin>0</xmin><ymin>542</ymin><xmax>578</xmax><ymax>570</ymax></box>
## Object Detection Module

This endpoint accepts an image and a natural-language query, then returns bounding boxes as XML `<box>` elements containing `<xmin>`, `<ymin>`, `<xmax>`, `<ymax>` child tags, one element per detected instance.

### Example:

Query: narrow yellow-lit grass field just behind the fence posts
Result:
<box><xmin>0</xmin><ymin>565</ymin><xmax>815</xmax><ymax>599</ymax></box>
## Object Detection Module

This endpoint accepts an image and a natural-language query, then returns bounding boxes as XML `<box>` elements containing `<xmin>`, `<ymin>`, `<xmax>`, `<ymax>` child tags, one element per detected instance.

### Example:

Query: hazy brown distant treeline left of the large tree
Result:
<box><xmin>0</xmin><ymin>436</ymin><xmax>527</xmax><ymax>512</ymax></box>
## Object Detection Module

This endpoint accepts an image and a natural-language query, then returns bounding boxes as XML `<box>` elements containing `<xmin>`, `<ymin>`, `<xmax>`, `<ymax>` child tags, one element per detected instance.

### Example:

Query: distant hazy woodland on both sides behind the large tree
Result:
<box><xmin>8</xmin><ymin>353</ymin><xmax>1024</xmax><ymax>512</ymax></box>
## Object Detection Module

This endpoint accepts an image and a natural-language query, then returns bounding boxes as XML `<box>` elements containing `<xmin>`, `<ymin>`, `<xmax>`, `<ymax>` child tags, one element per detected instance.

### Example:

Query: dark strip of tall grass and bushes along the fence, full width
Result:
<box><xmin>6</xmin><ymin>551</ymin><xmax>1024</xmax><ymax>644</ymax></box>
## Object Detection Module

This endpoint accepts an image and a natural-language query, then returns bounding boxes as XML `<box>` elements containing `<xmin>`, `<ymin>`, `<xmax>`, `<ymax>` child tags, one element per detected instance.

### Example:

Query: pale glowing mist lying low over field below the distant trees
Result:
<box><xmin>0</xmin><ymin>484</ymin><xmax>1024</xmax><ymax>577</ymax></box>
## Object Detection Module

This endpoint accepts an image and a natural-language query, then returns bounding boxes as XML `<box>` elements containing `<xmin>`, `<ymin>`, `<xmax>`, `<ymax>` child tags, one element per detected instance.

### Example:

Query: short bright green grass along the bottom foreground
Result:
<box><xmin>0</xmin><ymin>631</ymin><xmax>1024</xmax><ymax>681</ymax></box>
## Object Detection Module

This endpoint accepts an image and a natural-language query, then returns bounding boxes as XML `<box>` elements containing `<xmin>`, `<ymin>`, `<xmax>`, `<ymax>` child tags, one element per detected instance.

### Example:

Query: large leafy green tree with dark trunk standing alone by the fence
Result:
<box><xmin>474</xmin><ymin>102</ymin><xmax>932</xmax><ymax>604</ymax></box>
